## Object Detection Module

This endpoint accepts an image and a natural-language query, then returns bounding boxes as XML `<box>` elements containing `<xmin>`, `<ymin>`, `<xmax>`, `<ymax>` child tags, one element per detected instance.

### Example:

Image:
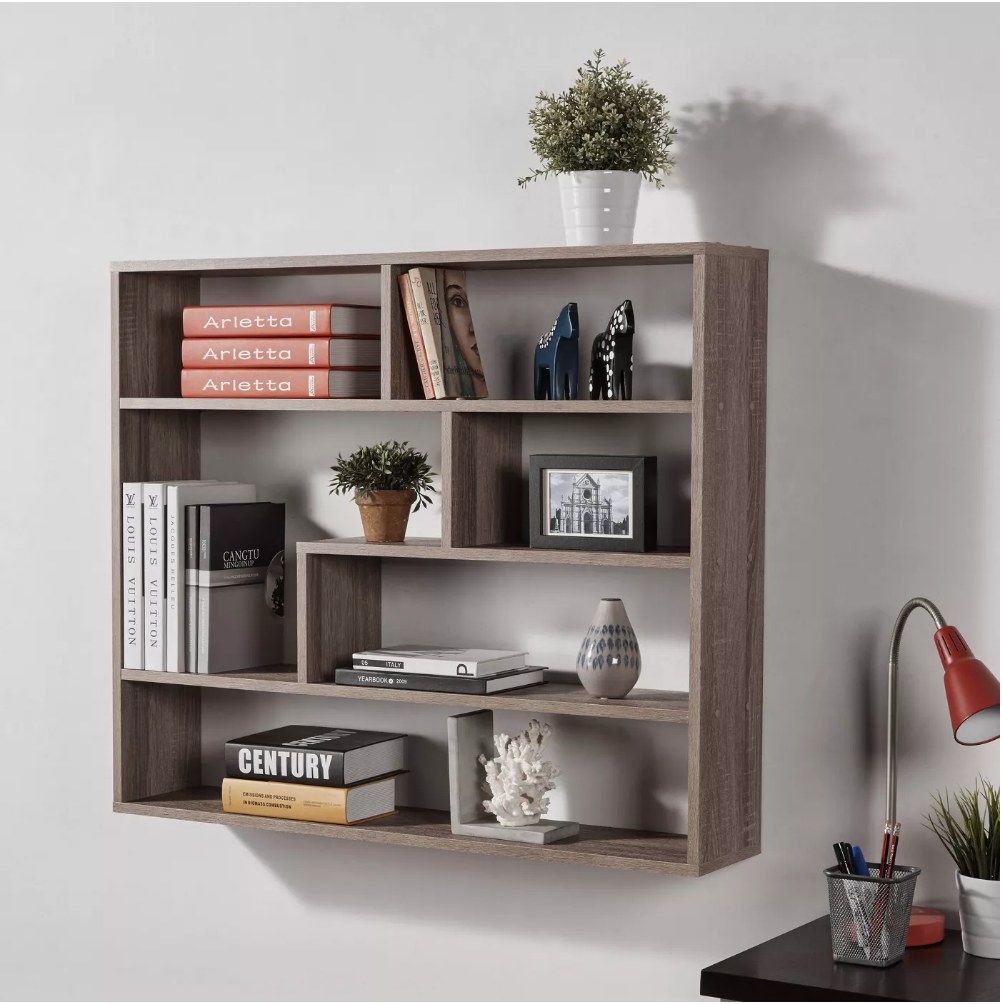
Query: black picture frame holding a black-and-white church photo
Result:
<box><xmin>529</xmin><ymin>453</ymin><xmax>658</xmax><ymax>551</ymax></box>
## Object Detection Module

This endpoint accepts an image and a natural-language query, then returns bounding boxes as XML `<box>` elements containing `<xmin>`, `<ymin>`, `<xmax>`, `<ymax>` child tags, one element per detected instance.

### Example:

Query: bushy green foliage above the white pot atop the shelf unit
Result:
<box><xmin>518</xmin><ymin>49</ymin><xmax>676</xmax><ymax>188</ymax></box>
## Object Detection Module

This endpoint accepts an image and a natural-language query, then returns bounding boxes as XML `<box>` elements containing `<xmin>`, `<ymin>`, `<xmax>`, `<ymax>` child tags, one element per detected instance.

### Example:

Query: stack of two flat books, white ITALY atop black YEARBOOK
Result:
<box><xmin>334</xmin><ymin>645</ymin><xmax>544</xmax><ymax>694</ymax></box>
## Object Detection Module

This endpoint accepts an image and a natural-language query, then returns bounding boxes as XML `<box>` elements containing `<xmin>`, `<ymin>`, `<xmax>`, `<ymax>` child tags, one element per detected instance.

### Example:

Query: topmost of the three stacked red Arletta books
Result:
<box><xmin>182</xmin><ymin>303</ymin><xmax>380</xmax><ymax>338</ymax></box>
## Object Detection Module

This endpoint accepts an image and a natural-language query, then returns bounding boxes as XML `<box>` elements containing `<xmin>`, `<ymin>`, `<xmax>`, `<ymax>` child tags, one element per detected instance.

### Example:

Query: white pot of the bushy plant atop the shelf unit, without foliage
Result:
<box><xmin>557</xmin><ymin>171</ymin><xmax>641</xmax><ymax>246</ymax></box>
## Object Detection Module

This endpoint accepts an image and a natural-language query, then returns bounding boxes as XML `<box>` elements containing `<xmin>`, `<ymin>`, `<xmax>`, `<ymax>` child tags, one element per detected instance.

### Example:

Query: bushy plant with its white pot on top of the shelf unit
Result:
<box><xmin>518</xmin><ymin>49</ymin><xmax>676</xmax><ymax>245</ymax></box>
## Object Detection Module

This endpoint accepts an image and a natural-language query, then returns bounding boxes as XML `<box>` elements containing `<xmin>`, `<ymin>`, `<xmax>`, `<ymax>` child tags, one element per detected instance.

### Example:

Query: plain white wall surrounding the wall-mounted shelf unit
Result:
<box><xmin>0</xmin><ymin>4</ymin><xmax>999</xmax><ymax>1000</ymax></box>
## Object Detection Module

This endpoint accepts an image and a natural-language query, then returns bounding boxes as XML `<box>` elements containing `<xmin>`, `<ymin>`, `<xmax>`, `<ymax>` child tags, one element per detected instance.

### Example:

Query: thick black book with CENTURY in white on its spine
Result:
<box><xmin>225</xmin><ymin>725</ymin><xmax>407</xmax><ymax>788</ymax></box>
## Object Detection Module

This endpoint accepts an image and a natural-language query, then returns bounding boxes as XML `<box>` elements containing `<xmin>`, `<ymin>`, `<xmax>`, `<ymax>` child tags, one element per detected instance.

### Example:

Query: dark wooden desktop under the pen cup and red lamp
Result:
<box><xmin>700</xmin><ymin>917</ymin><xmax>999</xmax><ymax>1001</ymax></box>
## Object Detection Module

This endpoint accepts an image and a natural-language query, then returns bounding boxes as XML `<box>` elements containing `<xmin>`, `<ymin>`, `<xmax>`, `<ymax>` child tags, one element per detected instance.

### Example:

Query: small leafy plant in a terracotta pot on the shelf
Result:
<box><xmin>330</xmin><ymin>440</ymin><xmax>435</xmax><ymax>544</ymax></box>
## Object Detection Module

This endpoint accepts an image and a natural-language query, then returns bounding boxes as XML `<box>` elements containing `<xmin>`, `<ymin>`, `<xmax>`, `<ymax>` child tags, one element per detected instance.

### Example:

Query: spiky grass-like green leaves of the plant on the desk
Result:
<box><xmin>926</xmin><ymin>777</ymin><xmax>999</xmax><ymax>882</ymax></box>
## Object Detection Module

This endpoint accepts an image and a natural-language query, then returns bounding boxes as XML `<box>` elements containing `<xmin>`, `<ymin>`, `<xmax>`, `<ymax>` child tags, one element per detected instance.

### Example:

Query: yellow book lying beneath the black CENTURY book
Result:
<box><xmin>223</xmin><ymin>777</ymin><xmax>397</xmax><ymax>824</ymax></box>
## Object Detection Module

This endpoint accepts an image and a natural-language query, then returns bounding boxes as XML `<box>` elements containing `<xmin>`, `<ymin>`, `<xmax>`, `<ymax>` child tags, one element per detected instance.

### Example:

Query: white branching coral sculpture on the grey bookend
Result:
<box><xmin>478</xmin><ymin>719</ymin><xmax>560</xmax><ymax>826</ymax></box>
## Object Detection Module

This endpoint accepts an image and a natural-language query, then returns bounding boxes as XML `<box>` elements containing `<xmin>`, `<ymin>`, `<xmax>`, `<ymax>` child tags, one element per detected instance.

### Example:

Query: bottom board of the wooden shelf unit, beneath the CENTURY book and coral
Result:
<box><xmin>114</xmin><ymin>787</ymin><xmax>695</xmax><ymax>874</ymax></box>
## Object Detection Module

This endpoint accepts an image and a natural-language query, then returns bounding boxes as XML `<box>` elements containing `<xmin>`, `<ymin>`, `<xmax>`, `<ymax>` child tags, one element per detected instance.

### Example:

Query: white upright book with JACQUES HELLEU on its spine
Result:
<box><xmin>164</xmin><ymin>481</ymin><xmax>257</xmax><ymax>673</ymax></box>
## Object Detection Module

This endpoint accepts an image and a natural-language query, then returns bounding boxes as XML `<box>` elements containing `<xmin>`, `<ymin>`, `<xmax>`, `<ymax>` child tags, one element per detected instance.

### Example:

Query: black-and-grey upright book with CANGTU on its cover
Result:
<box><xmin>197</xmin><ymin>502</ymin><xmax>285</xmax><ymax>673</ymax></box>
